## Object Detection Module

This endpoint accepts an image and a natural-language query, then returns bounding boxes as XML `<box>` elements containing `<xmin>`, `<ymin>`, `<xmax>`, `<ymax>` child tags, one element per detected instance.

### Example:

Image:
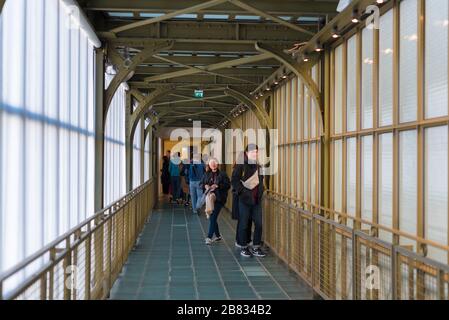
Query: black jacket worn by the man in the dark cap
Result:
<box><xmin>231</xmin><ymin>160</ymin><xmax>264</xmax><ymax>205</ymax></box>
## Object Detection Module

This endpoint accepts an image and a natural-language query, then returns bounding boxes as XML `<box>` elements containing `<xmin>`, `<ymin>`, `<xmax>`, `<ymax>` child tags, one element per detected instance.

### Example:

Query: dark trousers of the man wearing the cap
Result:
<box><xmin>237</xmin><ymin>201</ymin><xmax>262</xmax><ymax>247</ymax></box>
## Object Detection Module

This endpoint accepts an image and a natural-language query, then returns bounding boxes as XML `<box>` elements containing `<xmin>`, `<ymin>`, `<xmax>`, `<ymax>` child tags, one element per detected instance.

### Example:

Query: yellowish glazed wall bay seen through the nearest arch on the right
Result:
<box><xmin>273</xmin><ymin>74</ymin><xmax>320</xmax><ymax>203</ymax></box>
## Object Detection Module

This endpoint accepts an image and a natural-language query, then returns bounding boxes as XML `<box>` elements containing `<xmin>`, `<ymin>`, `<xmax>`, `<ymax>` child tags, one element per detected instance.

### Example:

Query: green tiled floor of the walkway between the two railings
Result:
<box><xmin>110</xmin><ymin>204</ymin><xmax>313</xmax><ymax>300</ymax></box>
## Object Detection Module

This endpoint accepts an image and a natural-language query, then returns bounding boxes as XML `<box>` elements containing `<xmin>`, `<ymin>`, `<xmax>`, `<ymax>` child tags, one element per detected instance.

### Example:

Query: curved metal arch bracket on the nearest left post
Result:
<box><xmin>104</xmin><ymin>41</ymin><xmax>174</xmax><ymax>117</ymax></box>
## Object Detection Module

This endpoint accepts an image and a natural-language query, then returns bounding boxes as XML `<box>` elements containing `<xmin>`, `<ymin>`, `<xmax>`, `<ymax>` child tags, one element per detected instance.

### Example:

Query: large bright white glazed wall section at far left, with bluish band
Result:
<box><xmin>0</xmin><ymin>0</ymin><xmax>95</xmax><ymax>276</ymax></box>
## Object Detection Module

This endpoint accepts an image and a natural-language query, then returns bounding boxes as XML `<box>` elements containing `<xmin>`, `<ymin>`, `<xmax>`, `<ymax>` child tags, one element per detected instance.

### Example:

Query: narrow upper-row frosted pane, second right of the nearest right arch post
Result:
<box><xmin>346</xmin><ymin>36</ymin><xmax>357</xmax><ymax>131</ymax></box>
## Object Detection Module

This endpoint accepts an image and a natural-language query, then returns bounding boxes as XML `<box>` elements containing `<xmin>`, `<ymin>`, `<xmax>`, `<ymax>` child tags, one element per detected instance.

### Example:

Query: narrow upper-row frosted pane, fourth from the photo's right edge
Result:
<box><xmin>361</xmin><ymin>28</ymin><xmax>374</xmax><ymax>129</ymax></box>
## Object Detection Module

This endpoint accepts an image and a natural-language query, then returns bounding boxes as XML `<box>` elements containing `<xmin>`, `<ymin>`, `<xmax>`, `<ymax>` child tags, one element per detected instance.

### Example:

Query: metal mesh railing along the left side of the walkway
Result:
<box><xmin>0</xmin><ymin>181</ymin><xmax>155</xmax><ymax>300</ymax></box>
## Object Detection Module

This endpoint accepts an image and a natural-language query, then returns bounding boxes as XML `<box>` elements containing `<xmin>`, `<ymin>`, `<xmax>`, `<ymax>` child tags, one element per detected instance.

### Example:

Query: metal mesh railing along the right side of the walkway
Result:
<box><xmin>264</xmin><ymin>192</ymin><xmax>449</xmax><ymax>299</ymax></box>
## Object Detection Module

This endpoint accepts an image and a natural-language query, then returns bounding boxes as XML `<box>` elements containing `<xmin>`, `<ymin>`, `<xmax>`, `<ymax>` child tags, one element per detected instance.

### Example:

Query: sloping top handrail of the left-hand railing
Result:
<box><xmin>0</xmin><ymin>179</ymin><xmax>154</xmax><ymax>300</ymax></box>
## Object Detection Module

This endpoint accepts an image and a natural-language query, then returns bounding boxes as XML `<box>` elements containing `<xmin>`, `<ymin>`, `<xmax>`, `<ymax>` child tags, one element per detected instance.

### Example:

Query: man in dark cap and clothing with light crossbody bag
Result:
<box><xmin>231</xmin><ymin>144</ymin><xmax>265</xmax><ymax>257</ymax></box>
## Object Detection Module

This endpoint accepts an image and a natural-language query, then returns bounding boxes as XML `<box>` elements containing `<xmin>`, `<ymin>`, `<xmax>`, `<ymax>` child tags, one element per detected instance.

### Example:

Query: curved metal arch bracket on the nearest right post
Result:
<box><xmin>252</xmin><ymin>42</ymin><xmax>323</xmax><ymax>124</ymax></box>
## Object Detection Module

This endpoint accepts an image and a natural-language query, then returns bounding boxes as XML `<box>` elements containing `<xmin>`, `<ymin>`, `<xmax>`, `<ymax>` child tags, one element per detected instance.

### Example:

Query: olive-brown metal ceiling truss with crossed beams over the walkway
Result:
<box><xmin>79</xmin><ymin>0</ymin><xmax>338</xmax><ymax>132</ymax></box>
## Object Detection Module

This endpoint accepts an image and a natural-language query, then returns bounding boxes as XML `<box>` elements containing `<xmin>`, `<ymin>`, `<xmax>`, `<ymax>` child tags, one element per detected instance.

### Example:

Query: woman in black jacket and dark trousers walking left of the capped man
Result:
<box><xmin>200</xmin><ymin>158</ymin><xmax>231</xmax><ymax>245</ymax></box>
